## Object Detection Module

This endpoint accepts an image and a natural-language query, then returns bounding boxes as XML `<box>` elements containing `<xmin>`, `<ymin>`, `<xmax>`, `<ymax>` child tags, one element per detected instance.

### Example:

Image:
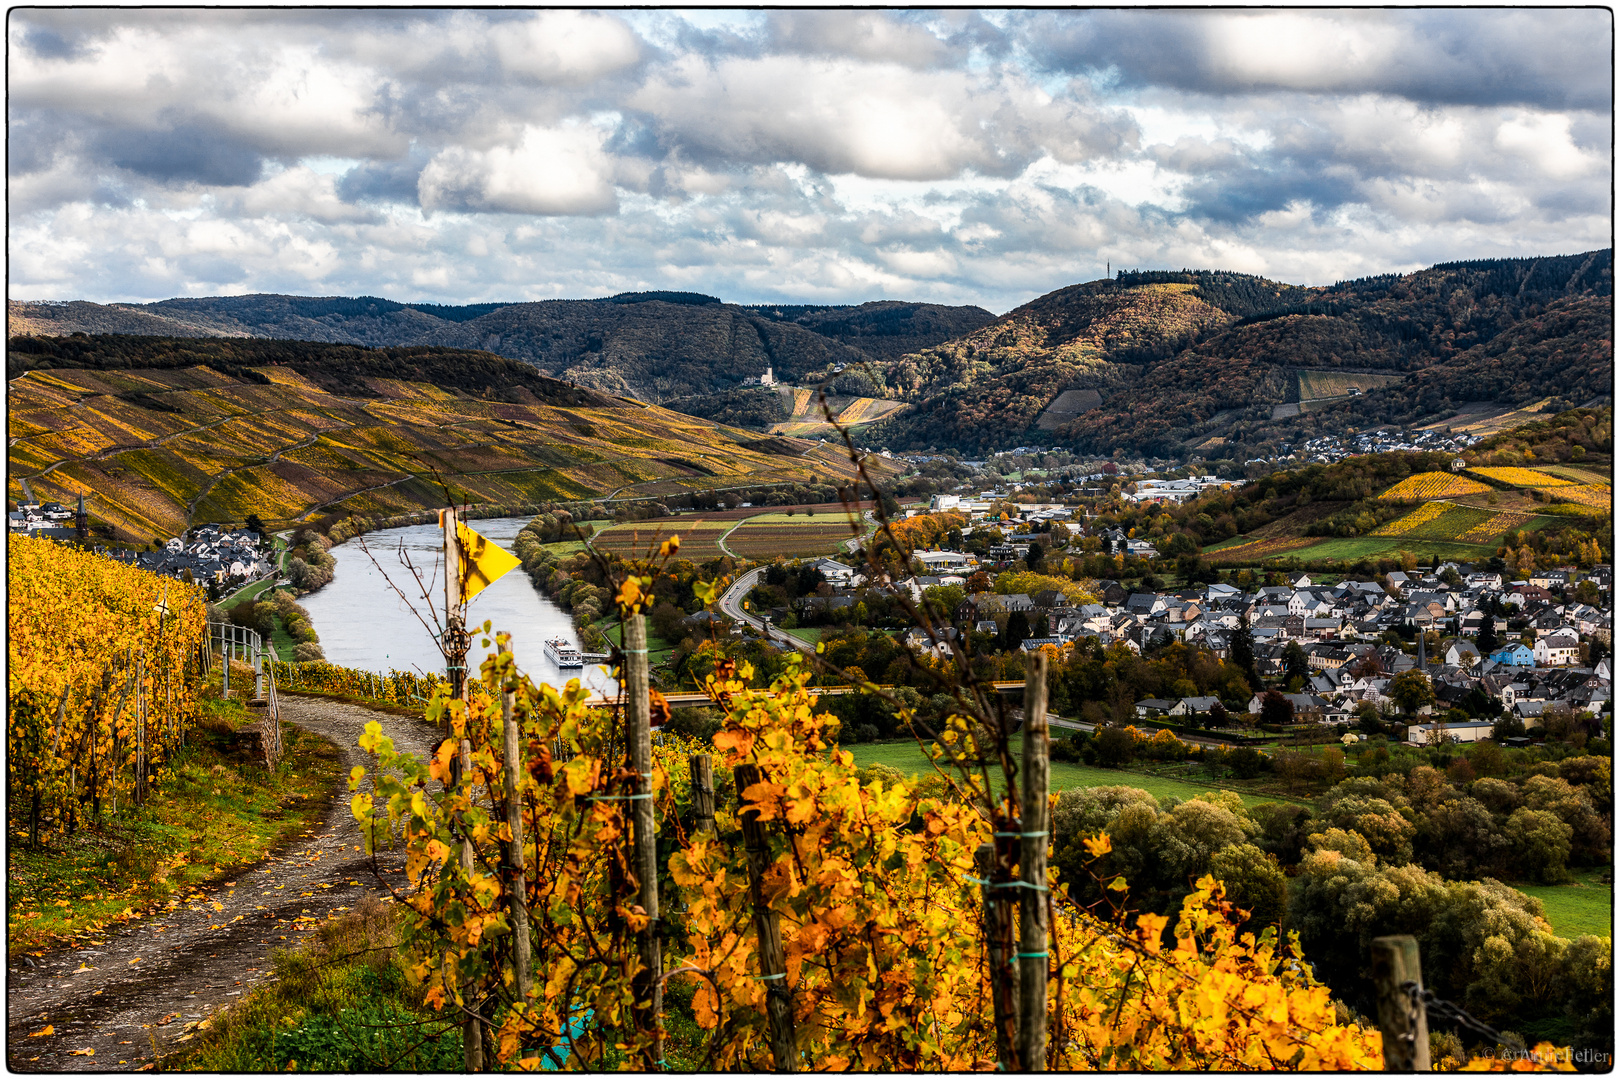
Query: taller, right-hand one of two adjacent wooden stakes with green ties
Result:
<box><xmin>1017</xmin><ymin>653</ymin><xmax>1051</xmax><ymax>1072</ymax></box>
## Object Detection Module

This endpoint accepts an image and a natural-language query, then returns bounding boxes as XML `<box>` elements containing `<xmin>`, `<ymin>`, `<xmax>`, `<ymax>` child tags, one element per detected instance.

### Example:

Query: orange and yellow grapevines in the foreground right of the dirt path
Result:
<box><xmin>350</xmin><ymin>641</ymin><xmax>1406</xmax><ymax>1072</ymax></box>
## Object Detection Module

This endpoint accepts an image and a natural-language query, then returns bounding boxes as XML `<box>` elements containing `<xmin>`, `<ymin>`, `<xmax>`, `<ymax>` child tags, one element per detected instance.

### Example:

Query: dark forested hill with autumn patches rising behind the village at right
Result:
<box><xmin>868</xmin><ymin>249</ymin><xmax>1614</xmax><ymax>457</ymax></box>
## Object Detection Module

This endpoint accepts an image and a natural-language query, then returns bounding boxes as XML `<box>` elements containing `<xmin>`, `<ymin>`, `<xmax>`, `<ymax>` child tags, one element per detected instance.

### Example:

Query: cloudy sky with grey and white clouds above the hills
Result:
<box><xmin>6</xmin><ymin>8</ymin><xmax>1614</xmax><ymax>314</ymax></box>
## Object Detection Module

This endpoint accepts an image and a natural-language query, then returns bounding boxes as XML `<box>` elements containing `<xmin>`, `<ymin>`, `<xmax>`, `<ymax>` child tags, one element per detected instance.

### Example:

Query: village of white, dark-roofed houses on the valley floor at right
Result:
<box><xmin>734</xmin><ymin>497</ymin><xmax>1614</xmax><ymax>745</ymax></box>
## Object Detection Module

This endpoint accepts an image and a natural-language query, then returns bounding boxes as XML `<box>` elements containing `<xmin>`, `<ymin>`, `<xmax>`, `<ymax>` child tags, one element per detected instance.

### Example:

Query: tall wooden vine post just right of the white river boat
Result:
<box><xmin>624</xmin><ymin>612</ymin><xmax>664</xmax><ymax>1072</ymax></box>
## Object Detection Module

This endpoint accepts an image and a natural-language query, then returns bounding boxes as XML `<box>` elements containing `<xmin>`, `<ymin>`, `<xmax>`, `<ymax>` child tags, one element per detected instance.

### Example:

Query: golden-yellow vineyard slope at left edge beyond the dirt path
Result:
<box><xmin>6</xmin><ymin>536</ymin><xmax>207</xmax><ymax>842</ymax></box>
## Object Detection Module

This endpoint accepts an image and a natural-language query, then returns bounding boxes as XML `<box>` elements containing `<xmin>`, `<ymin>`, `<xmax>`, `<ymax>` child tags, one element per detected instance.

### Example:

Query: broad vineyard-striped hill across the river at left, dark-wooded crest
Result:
<box><xmin>6</xmin><ymin>335</ymin><xmax>887</xmax><ymax>541</ymax></box>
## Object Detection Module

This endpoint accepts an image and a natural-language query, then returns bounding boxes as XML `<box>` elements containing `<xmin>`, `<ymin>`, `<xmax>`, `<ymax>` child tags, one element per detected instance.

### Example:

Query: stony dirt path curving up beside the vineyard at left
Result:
<box><xmin>6</xmin><ymin>695</ymin><xmax>450</xmax><ymax>1072</ymax></box>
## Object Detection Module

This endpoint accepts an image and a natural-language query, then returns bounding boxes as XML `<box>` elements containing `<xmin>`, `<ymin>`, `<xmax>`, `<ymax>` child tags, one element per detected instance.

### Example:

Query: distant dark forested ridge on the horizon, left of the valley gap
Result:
<box><xmin>8</xmin><ymin>291</ymin><xmax>993</xmax><ymax>402</ymax></box>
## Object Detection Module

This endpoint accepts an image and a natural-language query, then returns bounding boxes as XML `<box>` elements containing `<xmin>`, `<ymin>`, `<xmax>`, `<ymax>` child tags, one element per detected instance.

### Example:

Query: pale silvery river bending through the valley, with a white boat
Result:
<box><xmin>300</xmin><ymin>518</ymin><xmax>614</xmax><ymax>693</ymax></box>
